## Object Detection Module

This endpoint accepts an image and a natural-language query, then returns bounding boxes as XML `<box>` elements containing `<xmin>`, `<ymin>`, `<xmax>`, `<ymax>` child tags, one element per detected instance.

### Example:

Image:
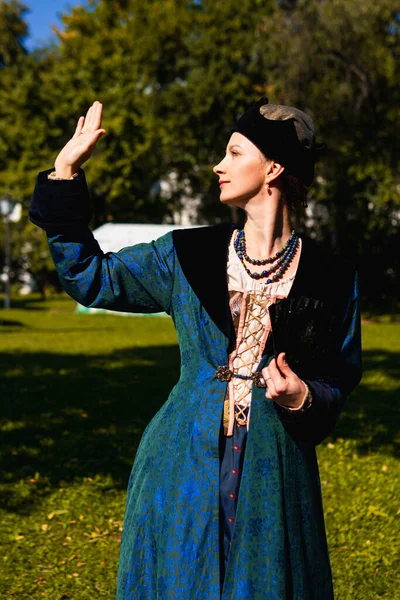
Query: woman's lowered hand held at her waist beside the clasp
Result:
<box><xmin>262</xmin><ymin>352</ymin><xmax>307</xmax><ymax>408</ymax></box>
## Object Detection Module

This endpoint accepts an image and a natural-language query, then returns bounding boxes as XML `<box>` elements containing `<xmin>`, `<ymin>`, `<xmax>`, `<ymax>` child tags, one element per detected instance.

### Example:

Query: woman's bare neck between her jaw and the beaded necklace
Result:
<box><xmin>244</xmin><ymin>195</ymin><xmax>292</xmax><ymax>258</ymax></box>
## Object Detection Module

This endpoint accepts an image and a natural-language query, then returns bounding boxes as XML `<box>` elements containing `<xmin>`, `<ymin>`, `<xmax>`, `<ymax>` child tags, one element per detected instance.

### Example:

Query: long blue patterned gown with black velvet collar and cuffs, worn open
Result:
<box><xmin>30</xmin><ymin>171</ymin><xmax>360</xmax><ymax>600</ymax></box>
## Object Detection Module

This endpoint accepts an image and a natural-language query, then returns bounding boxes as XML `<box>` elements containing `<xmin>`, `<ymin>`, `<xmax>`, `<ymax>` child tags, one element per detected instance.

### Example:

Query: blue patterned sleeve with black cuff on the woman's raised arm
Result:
<box><xmin>29</xmin><ymin>170</ymin><xmax>175</xmax><ymax>313</ymax></box>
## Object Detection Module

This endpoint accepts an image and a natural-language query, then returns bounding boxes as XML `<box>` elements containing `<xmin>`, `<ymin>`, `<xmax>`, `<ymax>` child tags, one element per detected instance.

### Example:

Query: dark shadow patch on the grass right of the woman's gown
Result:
<box><xmin>334</xmin><ymin>349</ymin><xmax>400</xmax><ymax>456</ymax></box>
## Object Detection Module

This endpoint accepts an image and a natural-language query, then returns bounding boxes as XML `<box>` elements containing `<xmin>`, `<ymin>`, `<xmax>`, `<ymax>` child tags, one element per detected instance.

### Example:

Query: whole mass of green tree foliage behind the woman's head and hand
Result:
<box><xmin>0</xmin><ymin>0</ymin><xmax>400</xmax><ymax>310</ymax></box>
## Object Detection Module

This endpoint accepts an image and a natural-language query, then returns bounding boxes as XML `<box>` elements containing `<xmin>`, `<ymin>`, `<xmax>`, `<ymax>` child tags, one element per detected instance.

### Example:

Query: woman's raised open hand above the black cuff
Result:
<box><xmin>54</xmin><ymin>100</ymin><xmax>106</xmax><ymax>179</ymax></box>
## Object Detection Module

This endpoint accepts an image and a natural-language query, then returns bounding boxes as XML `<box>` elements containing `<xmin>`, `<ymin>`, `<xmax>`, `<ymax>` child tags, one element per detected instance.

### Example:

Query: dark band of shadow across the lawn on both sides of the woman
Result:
<box><xmin>0</xmin><ymin>346</ymin><xmax>400</xmax><ymax>514</ymax></box>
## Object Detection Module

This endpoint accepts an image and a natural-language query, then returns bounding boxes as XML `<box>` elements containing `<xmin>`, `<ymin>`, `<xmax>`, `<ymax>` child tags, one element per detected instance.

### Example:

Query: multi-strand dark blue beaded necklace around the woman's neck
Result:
<box><xmin>234</xmin><ymin>229</ymin><xmax>299</xmax><ymax>283</ymax></box>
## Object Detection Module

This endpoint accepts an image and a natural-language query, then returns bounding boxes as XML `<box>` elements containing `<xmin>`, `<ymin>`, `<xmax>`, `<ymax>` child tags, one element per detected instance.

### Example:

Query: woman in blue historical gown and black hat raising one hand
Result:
<box><xmin>30</xmin><ymin>98</ymin><xmax>361</xmax><ymax>600</ymax></box>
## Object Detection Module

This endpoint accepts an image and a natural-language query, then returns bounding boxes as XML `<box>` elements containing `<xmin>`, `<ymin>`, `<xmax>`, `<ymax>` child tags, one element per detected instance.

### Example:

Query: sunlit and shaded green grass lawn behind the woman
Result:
<box><xmin>0</xmin><ymin>297</ymin><xmax>400</xmax><ymax>600</ymax></box>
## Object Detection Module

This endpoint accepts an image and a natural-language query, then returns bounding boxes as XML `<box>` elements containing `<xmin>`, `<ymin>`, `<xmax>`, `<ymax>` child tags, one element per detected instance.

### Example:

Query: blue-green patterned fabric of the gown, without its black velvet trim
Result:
<box><xmin>44</xmin><ymin>230</ymin><xmax>357</xmax><ymax>600</ymax></box>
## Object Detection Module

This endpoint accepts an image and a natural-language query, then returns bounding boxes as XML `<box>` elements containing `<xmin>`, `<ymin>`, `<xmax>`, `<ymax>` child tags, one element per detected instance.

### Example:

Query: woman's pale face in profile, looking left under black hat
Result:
<box><xmin>213</xmin><ymin>131</ymin><xmax>268</xmax><ymax>207</ymax></box>
